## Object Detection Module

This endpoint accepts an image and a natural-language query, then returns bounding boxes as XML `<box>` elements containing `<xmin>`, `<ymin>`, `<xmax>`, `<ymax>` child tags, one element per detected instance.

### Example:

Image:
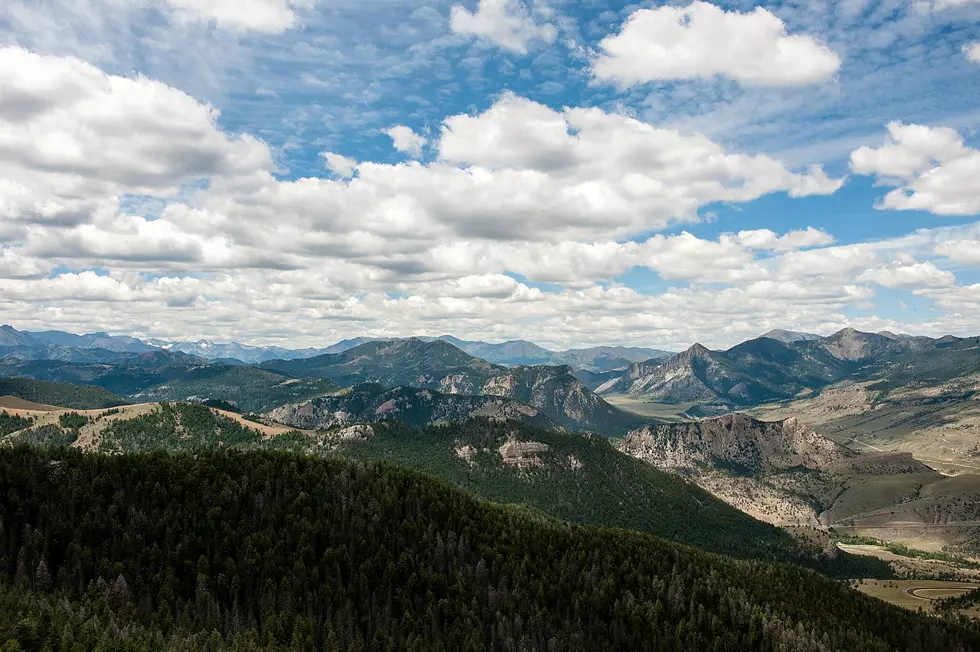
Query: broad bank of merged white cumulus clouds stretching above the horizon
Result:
<box><xmin>0</xmin><ymin>48</ymin><xmax>980</xmax><ymax>346</ymax></box>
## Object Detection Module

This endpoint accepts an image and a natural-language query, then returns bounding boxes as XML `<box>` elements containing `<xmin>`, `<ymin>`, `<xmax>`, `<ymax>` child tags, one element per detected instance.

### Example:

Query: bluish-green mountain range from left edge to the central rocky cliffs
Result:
<box><xmin>0</xmin><ymin>329</ymin><xmax>644</xmax><ymax>435</ymax></box>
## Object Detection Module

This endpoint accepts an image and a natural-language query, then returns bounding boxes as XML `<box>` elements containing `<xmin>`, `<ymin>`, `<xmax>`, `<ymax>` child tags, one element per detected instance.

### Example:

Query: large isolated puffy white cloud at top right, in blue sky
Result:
<box><xmin>592</xmin><ymin>1</ymin><xmax>841</xmax><ymax>87</ymax></box>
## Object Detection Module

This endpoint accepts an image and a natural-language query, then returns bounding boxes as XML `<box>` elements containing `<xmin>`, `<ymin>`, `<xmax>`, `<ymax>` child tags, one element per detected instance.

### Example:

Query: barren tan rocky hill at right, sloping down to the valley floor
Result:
<box><xmin>617</xmin><ymin>414</ymin><xmax>980</xmax><ymax>553</ymax></box>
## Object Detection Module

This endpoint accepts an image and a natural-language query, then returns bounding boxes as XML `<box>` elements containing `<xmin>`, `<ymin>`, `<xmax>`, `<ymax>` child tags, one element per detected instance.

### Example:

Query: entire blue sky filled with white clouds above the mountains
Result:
<box><xmin>0</xmin><ymin>0</ymin><xmax>980</xmax><ymax>349</ymax></box>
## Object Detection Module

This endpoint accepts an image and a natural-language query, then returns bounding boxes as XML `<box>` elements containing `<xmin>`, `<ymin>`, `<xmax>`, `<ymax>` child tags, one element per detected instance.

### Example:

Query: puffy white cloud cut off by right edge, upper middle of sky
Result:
<box><xmin>851</xmin><ymin>122</ymin><xmax>980</xmax><ymax>215</ymax></box>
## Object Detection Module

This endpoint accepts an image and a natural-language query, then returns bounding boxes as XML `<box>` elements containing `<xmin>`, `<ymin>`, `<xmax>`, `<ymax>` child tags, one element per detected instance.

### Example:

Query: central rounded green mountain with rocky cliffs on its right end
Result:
<box><xmin>261</xmin><ymin>339</ymin><xmax>639</xmax><ymax>434</ymax></box>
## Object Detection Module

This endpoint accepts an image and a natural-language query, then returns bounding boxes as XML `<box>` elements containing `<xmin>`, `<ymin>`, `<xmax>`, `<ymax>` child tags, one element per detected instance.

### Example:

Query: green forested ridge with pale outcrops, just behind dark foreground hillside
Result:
<box><xmin>21</xmin><ymin>403</ymin><xmax>889</xmax><ymax>577</ymax></box>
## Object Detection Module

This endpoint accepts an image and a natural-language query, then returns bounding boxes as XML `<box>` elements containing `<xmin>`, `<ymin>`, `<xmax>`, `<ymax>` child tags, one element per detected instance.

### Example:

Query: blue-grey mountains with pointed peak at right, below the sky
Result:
<box><xmin>597</xmin><ymin>329</ymin><xmax>964</xmax><ymax>410</ymax></box>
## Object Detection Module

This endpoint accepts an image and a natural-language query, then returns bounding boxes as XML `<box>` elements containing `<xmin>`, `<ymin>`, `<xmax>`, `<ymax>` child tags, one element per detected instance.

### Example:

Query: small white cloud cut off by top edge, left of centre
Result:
<box><xmin>166</xmin><ymin>0</ymin><xmax>311</xmax><ymax>34</ymax></box>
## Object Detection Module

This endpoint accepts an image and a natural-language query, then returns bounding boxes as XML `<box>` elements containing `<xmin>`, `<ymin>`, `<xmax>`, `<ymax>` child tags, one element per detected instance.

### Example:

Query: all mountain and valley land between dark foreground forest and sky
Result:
<box><xmin>0</xmin><ymin>331</ymin><xmax>980</xmax><ymax>616</ymax></box>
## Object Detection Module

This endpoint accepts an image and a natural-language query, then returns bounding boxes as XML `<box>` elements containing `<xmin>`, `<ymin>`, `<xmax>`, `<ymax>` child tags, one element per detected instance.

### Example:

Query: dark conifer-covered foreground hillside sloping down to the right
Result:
<box><xmin>0</xmin><ymin>448</ymin><xmax>980</xmax><ymax>652</ymax></box>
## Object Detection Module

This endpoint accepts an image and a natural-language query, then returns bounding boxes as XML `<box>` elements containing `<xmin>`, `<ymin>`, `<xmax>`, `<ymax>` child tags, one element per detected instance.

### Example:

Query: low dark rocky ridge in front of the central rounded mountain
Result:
<box><xmin>266</xmin><ymin>384</ymin><xmax>557</xmax><ymax>430</ymax></box>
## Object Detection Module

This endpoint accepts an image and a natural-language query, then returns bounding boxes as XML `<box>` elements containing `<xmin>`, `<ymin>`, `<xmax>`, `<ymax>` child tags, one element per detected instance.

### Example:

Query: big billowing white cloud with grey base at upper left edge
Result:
<box><xmin>0</xmin><ymin>47</ymin><xmax>274</xmax><ymax>232</ymax></box>
